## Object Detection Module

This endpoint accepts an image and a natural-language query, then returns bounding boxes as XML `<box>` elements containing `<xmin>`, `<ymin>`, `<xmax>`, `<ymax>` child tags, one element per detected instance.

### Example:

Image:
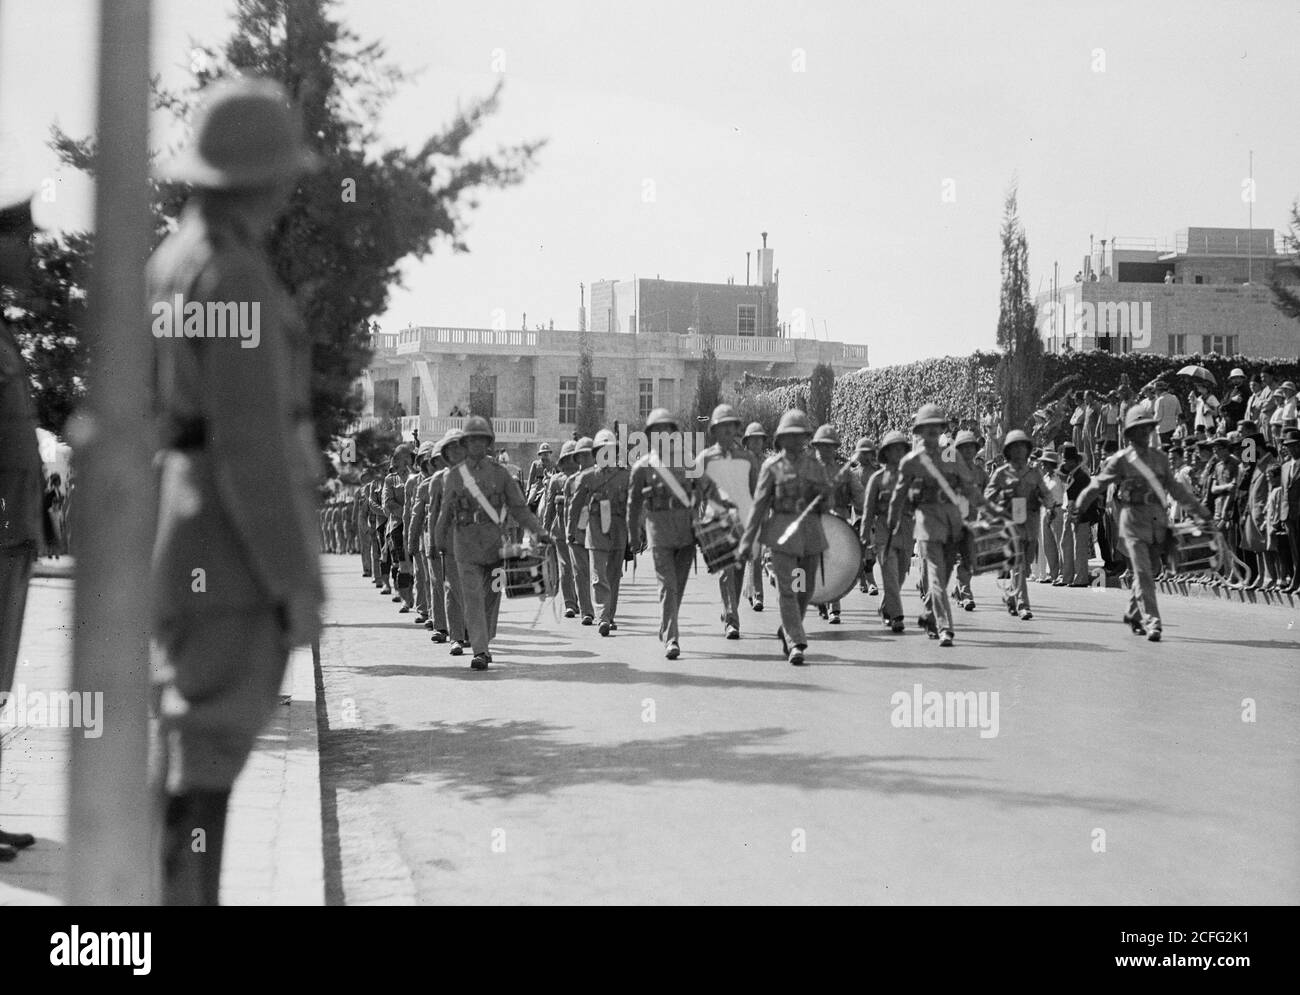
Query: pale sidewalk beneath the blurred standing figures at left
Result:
<box><xmin>0</xmin><ymin>569</ymin><xmax>325</xmax><ymax>905</ymax></box>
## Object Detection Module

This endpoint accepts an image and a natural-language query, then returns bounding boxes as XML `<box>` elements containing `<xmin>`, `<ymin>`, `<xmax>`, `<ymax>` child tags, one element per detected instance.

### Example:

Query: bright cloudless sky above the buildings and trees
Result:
<box><xmin>0</xmin><ymin>0</ymin><xmax>1300</xmax><ymax>367</ymax></box>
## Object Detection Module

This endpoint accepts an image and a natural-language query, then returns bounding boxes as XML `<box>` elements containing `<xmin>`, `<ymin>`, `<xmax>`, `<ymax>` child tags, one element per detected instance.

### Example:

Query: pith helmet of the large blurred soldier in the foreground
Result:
<box><xmin>164</xmin><ymin>75</ymin><xmax>320</xmax><ymax>190</ymax></box>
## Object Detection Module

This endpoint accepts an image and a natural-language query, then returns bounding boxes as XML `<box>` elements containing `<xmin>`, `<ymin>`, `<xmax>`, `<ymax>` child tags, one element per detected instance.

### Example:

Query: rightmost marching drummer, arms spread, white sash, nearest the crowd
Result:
<box><xmin>1070</xmin><ymin>405</ymin><xmax>1210</xmax><ymax>643</ymax></box>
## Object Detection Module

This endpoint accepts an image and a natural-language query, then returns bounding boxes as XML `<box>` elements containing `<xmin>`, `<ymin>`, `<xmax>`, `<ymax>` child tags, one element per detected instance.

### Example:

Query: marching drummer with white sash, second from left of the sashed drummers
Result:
<box><xmin>628</xmin><ymin>407</ymin><xmax>716</xmax><ymax>659</ymax></box>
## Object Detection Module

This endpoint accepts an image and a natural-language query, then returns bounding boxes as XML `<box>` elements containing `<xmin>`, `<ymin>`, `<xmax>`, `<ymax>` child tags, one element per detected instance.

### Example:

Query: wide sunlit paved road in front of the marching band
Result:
<box><xmin>321</xmin><ymin>557</ymin><xmax>1300</xmax><ymax>904</ymax></box>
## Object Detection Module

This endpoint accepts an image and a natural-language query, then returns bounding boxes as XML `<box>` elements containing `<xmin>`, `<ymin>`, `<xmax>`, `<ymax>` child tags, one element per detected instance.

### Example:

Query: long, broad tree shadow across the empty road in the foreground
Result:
<box><xmin>322</xmin><ymin>721</ymin><xmax>1161</xmax><ymax>814</ymax></box>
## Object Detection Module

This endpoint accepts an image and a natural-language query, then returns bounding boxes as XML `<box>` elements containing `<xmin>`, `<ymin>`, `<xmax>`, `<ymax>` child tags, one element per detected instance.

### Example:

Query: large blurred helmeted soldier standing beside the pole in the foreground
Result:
<box><xmin>148</xmin><ymin>77</ymin><xmax>324</xmax><ymax>905</ymax></box>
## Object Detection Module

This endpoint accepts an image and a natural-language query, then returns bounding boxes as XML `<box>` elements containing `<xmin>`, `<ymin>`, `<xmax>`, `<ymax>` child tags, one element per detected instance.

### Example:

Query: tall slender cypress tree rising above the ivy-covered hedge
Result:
<box><xmin>997</xmin><ymin>182</ymin><xmax>1043</xmax><ymax>431</ymax></box>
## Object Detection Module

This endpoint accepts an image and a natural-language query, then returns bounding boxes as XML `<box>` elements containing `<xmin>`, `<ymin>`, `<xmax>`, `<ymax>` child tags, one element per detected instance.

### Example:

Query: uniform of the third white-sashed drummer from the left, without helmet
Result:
<box><xmin>889</xmin><ymin>449</ymin><xmax>982</xmax><ymax>631</ymax></box>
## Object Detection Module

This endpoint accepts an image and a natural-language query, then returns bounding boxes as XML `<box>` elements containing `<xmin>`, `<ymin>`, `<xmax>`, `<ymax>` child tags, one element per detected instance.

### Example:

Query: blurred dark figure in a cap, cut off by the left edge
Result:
<box><xmin>0</xmin><ymin>189</ymin><xmax>43</xmax><ymax>861</ymax></box>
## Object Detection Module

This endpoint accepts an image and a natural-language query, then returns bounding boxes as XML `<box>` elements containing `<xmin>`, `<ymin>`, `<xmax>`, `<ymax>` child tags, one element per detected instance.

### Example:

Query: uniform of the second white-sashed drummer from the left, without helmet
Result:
<box><xmin>628</xmin><ymin>454</ymin><xmax>716</xmax><ymax>643</ymax></box>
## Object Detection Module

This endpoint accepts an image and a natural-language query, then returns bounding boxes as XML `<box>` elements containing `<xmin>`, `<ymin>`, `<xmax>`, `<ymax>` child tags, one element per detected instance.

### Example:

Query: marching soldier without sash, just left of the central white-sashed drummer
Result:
<box><xmin>564</xmin><ymin>428</ymin><xmax>631</xmax><ymax>636</ymax></box>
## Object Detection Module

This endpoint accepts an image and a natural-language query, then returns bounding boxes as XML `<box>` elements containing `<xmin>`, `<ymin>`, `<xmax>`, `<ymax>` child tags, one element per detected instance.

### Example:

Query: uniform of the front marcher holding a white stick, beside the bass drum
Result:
<box><xmin>741</xmin><ymin>451</ymin><xmax>832</xmax><ymax>649</ymax></box>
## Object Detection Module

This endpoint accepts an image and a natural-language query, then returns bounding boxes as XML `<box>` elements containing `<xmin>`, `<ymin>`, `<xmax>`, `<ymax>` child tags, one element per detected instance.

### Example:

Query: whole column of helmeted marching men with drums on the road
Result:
<box><xmin>335</xmin><ymin>392</ymin><xmax>1227</xmax><ymax>670</ymax></box>
